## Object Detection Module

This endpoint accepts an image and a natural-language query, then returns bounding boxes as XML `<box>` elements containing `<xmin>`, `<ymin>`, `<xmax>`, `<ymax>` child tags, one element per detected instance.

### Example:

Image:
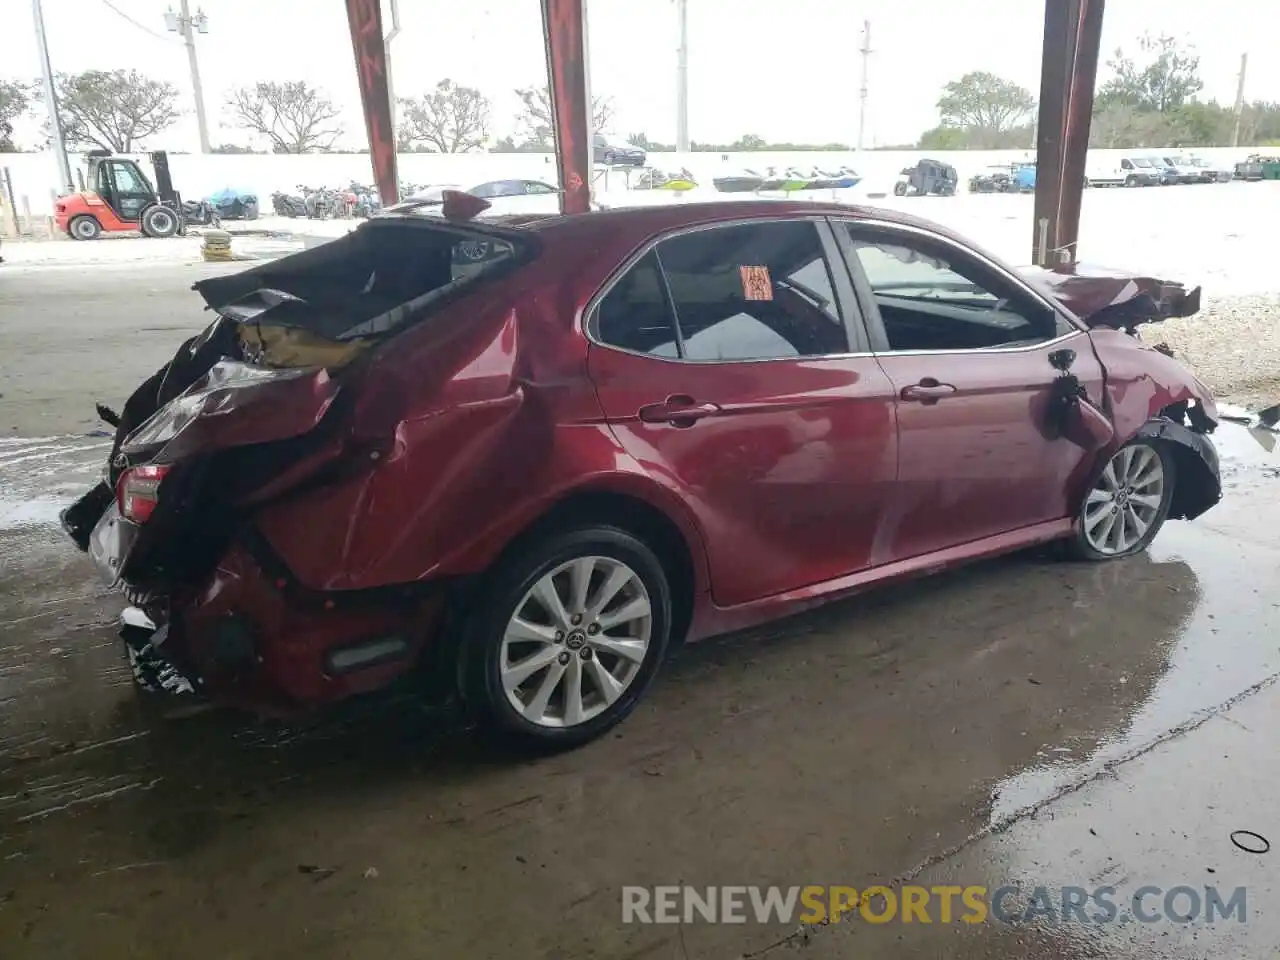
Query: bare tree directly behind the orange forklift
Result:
<box><xmin>48</xmin><ymin>70</ymin><xmax>182</xmax><ymax>154</ymax></box>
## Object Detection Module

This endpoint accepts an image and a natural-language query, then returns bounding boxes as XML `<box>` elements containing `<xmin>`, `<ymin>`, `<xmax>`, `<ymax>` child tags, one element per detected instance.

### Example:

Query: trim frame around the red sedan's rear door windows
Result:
<box><xmin>581</xmin><ymin>212</ymin><xmax>873</xmax><ymax>366</ymax></box>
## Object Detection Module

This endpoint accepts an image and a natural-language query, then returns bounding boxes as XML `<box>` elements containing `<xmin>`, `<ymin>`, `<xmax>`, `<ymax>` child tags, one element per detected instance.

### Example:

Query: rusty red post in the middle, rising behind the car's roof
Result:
<box><xmin>541</xmin><ymin>0</ymin><xmax>591</xmax><ymax>214</ymax></box>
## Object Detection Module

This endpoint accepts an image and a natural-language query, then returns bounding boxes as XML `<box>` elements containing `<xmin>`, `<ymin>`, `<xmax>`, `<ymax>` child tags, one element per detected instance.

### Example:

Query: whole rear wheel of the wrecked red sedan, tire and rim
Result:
<box><xmin>466</xmin><ymin>525</ymin><xmax>671</xmax><ymax>749</ymax></box>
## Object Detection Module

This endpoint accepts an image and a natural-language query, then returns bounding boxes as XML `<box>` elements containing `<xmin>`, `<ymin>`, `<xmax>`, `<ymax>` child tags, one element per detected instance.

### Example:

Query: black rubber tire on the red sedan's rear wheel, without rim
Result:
<box><xmin>462</xmin><ymin>524</ymin><xmax>671</xmax><ymax>751</ymax></box>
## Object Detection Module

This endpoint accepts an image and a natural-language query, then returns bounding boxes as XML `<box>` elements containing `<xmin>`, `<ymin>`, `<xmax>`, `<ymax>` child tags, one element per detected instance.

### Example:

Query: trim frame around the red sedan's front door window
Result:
<box><xmin>828</xmin><ymin>215</ymin><xmax>1088</xmax><ymax>357</ymax></box>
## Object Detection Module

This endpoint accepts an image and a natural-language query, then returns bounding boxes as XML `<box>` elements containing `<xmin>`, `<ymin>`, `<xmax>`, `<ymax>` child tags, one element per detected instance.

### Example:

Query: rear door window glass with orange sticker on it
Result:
<box><xmin>658</xmin><ymin>220</ymin><xmax>849</xmax><ymax>361</ymax></box>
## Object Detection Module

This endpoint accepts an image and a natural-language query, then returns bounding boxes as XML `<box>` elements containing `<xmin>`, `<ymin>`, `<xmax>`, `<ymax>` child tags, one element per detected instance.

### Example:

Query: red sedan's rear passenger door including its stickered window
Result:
<box><xmin>588</xmin><ymin>219</ymin><xmax>897</xmax><ymax>605</ymax></box>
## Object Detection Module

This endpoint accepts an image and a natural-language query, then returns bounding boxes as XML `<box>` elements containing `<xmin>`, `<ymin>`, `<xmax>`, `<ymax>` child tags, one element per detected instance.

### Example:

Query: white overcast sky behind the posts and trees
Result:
<box><xmin>0</xmin><ymin>0</ymin><xmax>1280</xmax><ymax>150</ymax></box>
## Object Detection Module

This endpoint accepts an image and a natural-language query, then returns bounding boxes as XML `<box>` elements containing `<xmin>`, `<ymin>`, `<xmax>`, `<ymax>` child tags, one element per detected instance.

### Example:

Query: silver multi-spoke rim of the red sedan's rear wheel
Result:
<box><xmin>498</xmin><ymin>557</ymin><xmax>653</xmax><ymax>727</ymax></box>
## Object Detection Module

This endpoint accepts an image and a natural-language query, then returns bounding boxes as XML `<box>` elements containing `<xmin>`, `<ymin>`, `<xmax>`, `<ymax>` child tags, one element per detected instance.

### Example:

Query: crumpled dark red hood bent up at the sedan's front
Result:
<box><xmin>1018</xmin><ymin>264</ymin><xmax>1201</xmax><ymax>332</ymax></box>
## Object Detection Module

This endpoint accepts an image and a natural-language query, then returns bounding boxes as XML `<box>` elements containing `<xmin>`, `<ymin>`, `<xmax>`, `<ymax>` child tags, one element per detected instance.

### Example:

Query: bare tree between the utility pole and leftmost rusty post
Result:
<box><xmin>227</xmin><ymin>81</ymin><xmax>343</xmax><ymax>154</ymax></box>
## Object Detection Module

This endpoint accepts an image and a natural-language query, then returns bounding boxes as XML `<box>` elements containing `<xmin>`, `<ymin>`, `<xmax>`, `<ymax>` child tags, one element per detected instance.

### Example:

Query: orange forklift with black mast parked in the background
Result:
<box><xmin>54</xmin><ymin>150</ymin><xmax>186</xmax><ymax>239</ymax></box>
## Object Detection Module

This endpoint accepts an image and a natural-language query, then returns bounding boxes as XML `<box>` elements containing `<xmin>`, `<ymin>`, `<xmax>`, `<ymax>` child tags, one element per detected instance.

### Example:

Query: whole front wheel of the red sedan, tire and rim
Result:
<box><xmin>1071</xmin><ymin>439</ymin><xmax>1176</xmax><ymax>561</ymax></box>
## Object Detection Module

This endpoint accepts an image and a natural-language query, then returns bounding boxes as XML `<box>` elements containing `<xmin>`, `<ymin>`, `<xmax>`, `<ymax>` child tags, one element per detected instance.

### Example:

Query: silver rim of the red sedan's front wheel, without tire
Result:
<box><xmin>1082</xmin><ymin>444</ymin><xmax>1165</xmax><ymax>557</ymax></box>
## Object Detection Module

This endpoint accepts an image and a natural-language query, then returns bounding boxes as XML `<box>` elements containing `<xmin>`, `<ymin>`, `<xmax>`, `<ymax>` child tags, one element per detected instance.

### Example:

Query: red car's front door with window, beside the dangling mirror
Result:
<box><xmin>836</xmin><ymin>220</ymin><xmax>1102</xmax><ymax>559</ymax></box>
